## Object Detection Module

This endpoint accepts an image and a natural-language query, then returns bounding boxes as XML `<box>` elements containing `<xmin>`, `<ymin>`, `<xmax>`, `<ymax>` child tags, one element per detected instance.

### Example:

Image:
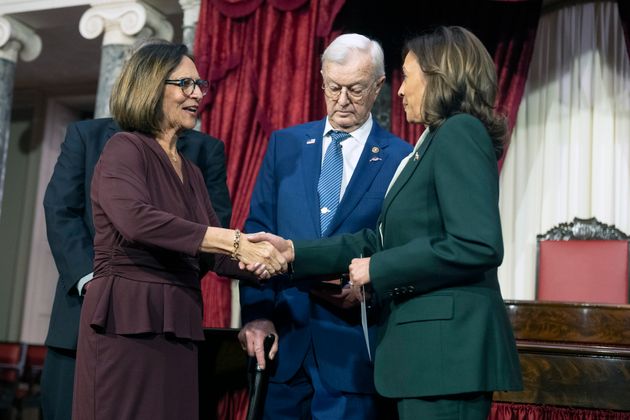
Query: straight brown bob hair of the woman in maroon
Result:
<box><xmin>109</xmin><ymin>42</ymin><xmax>192</xmax><ymax>135</ymax></box>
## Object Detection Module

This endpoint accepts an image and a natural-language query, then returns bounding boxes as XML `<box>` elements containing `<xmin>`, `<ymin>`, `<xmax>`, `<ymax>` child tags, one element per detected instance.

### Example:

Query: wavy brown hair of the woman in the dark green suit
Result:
<box><xmin>403</xmin><ymin>26</ymin><xmax>507</xmax><ymax>156</ymax></box>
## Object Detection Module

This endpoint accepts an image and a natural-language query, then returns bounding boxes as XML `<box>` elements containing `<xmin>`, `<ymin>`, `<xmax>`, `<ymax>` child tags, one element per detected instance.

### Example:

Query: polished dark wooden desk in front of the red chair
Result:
<box><xmin>494</xmin><ymin>301</ymin><xmax>630</xmax><ymax>411</ymax></box>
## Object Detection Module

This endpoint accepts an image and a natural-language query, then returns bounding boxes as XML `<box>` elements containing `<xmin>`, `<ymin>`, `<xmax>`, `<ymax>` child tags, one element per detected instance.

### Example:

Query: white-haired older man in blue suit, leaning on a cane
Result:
<box><xmin>239</xmin><ymin>34</ymin><xmax>411</xmax><ymax>420</ymax></box>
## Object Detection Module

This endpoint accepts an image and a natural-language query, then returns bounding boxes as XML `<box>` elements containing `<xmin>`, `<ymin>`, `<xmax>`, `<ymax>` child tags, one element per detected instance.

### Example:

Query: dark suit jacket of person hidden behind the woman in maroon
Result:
<box><xmin>44</xmin><ymin>118</ymin><xmax>232</xmax><ymax>349</ymax></box>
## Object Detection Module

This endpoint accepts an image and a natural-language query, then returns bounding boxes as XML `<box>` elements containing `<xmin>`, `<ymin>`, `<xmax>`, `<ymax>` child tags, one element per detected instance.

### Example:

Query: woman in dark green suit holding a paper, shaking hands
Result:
<box><xmin>247</xmin><ymin>27</ymin><xmax>522</xmax><ymax>420</ymax></box>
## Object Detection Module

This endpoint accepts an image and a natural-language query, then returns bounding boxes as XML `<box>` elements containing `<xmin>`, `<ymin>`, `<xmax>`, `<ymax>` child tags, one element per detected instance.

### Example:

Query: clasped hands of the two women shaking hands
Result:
<box><xmin>237</xmin><ymin>232</ymin><xmax>295</xmax><ymax>280</ymax></box>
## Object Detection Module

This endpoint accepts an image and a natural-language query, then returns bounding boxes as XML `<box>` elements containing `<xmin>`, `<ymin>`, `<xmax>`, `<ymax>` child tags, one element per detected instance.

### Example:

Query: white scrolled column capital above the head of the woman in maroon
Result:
<box><xmin>79</xmin><ymin>1</ymin><xmax>173</xmax><ymax>45</ymax></box>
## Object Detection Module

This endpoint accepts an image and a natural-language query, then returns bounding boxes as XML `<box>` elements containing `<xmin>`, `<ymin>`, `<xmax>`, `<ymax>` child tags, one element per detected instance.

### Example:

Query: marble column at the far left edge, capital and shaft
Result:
<box><xmin>0</xmin><ymin>16</ymin><xmax>42</xmax><ymax>217</ymax></box>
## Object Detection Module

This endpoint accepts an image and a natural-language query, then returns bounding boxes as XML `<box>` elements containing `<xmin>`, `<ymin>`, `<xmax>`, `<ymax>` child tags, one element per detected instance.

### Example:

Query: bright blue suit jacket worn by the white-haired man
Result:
<box><xmin>241</xmin><ymin>119</ymin><xmax>411</xmax><ymax>393</ymax></box>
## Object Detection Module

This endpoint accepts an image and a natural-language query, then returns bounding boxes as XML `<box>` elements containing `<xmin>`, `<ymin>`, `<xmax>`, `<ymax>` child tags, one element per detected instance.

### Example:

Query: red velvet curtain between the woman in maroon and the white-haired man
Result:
<box><xmin>195</xmin><ymin>0</ymin><xmax>343</xmax><ymax>327</ymax></box>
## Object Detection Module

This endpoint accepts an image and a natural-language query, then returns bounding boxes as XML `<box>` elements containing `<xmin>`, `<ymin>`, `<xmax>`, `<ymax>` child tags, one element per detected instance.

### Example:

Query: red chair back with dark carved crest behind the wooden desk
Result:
<box><xmin>536</xmin><ymin>217</ymin><xmax>630</xmax><ymax>304</ymax></box>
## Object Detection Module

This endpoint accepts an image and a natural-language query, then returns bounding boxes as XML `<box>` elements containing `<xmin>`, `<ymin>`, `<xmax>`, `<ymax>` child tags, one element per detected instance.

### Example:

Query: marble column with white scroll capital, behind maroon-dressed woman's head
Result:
<box><xmin>79</xmin><ymin>1</ymin><xmax>173</xmax><ymax>118</ymax></box>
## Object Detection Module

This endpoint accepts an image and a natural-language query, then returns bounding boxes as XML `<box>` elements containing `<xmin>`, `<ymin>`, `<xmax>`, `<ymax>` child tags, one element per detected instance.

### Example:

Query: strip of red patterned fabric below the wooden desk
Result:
<box><xmin>488</xmin><ymin>402</ymin><xmax>630</xmax><ymax>420</ymax></box>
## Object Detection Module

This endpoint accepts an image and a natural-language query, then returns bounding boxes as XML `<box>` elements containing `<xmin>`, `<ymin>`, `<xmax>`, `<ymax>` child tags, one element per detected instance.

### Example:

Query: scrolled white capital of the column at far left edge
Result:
<box><xmin>0</xmin><ymin>16</ymin><xmax>42</xmax><ymax>63</ymax></box>
